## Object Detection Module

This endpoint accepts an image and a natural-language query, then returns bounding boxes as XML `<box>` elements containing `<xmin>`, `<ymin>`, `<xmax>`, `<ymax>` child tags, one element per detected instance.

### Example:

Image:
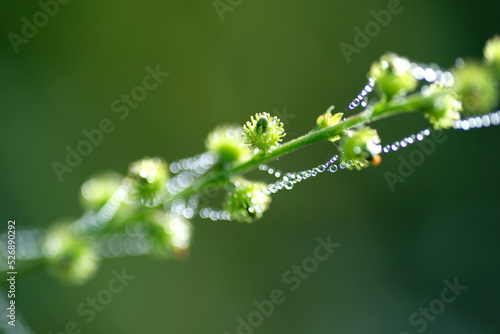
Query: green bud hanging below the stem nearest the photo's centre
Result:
<box><xmin>224</xmin><ymin>178</ymin><xmax>271</xmax><ymax>223</ymax></box>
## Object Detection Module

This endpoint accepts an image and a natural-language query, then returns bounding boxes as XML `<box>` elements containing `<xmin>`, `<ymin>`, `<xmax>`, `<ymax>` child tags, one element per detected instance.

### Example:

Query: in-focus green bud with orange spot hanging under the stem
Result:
<box><xmin>340</xmin><ymin>127</ymin><xmax>382</xmax><ymax>170</ymax></box>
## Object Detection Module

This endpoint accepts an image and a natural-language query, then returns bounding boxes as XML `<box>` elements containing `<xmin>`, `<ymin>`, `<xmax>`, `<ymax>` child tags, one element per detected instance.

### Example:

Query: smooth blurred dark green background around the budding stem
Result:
<box><xmin>0</xmin><ymin>0</ymin><xmax>500</xmax><ymax>334</ymax></box>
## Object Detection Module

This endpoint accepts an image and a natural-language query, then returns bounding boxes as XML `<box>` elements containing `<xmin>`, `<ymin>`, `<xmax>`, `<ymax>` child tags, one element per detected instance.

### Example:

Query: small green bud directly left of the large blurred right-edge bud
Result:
<box><xmin>423</xmin><ymin>84</ymin><xmax>462</xmax><ymax>130</ymax></box>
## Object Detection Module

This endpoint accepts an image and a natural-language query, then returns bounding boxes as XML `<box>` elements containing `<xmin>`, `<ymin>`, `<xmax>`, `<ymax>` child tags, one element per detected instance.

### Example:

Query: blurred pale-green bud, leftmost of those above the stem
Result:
<box><xmin>80</xmin><ymin>172</ymin><xmax>123</xmax><ymax>210</ymax></box>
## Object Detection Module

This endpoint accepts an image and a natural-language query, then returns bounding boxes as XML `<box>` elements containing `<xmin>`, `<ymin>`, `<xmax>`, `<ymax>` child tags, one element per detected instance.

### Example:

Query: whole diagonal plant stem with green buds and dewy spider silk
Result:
<box><xmin>30</xmin><ymin>36</ymin><xmax>500</xmax><ymax>284</ymax></box>
